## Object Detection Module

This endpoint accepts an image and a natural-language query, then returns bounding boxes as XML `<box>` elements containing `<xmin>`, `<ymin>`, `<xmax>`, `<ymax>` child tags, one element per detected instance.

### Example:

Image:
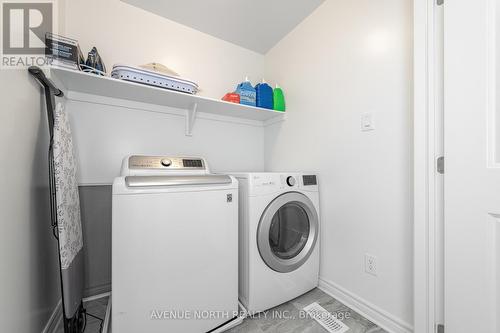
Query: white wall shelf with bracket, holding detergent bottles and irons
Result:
<box><xmin>47</xmin><ymin>67</ymin><xmax>285</xmax><ymax>135</ymax></box>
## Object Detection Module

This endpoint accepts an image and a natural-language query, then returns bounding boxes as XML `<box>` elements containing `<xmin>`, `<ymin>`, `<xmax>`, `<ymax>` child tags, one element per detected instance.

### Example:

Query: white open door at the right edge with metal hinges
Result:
<box><xmin>444</xmin><ymin>0</ymin><xmax>500</xmax><ymax>333</ymax></box>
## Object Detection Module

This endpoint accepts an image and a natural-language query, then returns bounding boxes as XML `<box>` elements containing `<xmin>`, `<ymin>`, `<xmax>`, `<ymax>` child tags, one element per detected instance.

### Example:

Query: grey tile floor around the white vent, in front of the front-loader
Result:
<box><xmin>227</xmin><ymin>289</ymin><xmax>387</xmax><ymax>333</ymax></box>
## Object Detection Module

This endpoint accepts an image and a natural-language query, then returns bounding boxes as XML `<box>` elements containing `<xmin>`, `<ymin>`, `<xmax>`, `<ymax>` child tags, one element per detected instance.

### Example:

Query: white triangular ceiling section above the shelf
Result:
<box><xmin>122</xmin><ymin>0</ymin><xmax>325</xmax><ymax>54</ymax></box>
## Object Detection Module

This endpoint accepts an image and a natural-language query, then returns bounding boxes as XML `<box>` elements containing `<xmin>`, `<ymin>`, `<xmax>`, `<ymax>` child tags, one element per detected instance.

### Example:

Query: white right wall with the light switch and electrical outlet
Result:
<box><xmin>265</xmin><ymin>0</ymin><xmax>413</xmax><ymax>328</ymax></box>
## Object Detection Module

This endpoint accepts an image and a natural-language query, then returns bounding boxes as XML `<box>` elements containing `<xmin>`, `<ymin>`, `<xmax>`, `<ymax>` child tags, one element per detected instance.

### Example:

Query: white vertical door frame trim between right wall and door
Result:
<box><xmin>413</xmin><ymin>0</ymin><xmax>437</xmax><ymax>333</ymax></box>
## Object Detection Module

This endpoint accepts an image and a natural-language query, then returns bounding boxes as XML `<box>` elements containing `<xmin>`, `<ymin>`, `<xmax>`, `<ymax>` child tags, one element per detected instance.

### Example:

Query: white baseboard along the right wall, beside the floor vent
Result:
<box><xmin>319</xmin><ymin>277</ymin><xmax>413</xmax><ymax>333</ymax></box>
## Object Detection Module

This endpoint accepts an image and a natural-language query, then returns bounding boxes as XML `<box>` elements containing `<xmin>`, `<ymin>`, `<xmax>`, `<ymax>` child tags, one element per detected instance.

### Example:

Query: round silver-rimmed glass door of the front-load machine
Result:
<box><xmin>257</xmin><ymin>192</ymin><xmax>319</xmax><ymax>273</ymax></box>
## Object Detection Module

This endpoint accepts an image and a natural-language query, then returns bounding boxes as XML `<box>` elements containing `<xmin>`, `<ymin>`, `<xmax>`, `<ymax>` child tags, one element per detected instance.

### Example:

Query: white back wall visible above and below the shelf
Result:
<box><xmin>64</xmin><ymin>0</ymin><xmax>270</xmax><ymax>184</ymax></box>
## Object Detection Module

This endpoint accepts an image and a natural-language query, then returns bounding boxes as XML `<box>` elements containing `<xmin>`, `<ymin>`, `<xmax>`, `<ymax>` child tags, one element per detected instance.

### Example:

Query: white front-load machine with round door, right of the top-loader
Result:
<box><xmin>233</xmin><ymin>173</ymin><xmax>320</xmax><ymax>313</ymax></box>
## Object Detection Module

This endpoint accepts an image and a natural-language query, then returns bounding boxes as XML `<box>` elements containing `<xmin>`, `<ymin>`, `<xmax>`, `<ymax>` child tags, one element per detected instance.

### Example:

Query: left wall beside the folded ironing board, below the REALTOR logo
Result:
<box><xmin>0</xmin><ymin>70</ymin><xmax>60</xmax><ymax>333</ymax></box>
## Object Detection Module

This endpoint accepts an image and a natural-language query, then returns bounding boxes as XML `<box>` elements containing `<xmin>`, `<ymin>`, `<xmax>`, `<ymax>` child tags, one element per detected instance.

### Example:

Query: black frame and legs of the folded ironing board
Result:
<box><xmin>28</xmin><ymin>66</ymin><xmax>86</xmax><ymax>333</ymax></box>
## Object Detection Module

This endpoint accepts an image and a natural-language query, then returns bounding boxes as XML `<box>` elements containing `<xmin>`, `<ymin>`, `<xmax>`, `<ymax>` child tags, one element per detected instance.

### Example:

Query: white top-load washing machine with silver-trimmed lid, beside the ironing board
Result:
<box><xmin>112</xmin><ymin>156</ymin><xmax>238</xmax><ymax>333</ymax></box>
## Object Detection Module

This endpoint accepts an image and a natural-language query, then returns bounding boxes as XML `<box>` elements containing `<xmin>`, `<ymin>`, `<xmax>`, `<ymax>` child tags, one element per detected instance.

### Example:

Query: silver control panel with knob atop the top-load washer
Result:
<box><xmin>128</xmin><ymin>155</ymin><xmax>206</xmax><ymax>170</ymax></box>
